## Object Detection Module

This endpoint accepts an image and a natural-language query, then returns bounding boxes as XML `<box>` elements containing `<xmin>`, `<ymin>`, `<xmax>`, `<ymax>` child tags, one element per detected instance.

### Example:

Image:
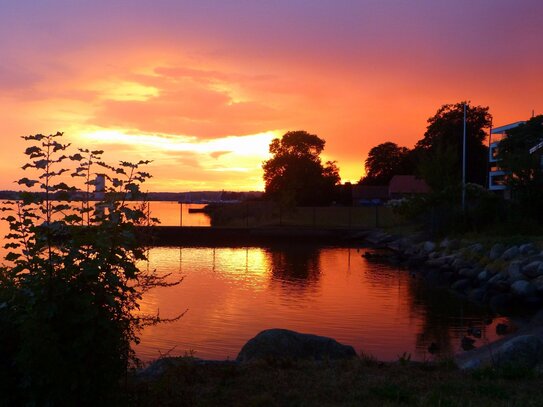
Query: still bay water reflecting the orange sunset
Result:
<box><xmin>1</xmin><ymin>202</ymin><xmax>508</xmax><ymax>361</ymax></box>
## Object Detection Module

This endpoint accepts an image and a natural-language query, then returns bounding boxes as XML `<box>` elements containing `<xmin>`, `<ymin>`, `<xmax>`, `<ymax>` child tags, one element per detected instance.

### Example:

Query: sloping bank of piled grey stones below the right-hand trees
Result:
<box><xmin>366</xmin><ymin>232</ymin><xmax>543</xmax><ymax>314</ymax></box>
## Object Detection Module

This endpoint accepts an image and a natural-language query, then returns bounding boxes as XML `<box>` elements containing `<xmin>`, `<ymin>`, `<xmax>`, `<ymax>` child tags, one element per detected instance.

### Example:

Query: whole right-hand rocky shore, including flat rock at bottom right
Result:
<box><xmin>363</xmin><ymin>232</ymin><xmax>543</xmax><ymax>370</ymax></box>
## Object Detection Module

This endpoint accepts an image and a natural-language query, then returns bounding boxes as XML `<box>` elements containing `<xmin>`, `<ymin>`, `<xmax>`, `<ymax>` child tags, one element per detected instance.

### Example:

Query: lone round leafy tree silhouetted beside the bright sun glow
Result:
<box><xmin>262</xmin><ymin>131</ymin><xmax>340</xmax><ymax>206</ymax></box>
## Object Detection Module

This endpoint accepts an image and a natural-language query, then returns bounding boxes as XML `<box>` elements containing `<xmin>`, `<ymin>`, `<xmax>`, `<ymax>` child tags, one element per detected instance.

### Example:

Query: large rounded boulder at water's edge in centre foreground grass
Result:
<box><xmin>236</xmin><ymin>329</ymin><xmax>356</xmax><ymax>362</ymax></box>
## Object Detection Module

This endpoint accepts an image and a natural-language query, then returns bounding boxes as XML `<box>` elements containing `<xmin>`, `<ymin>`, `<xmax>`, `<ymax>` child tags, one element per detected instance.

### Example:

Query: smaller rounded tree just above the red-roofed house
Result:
<box><xmin>360</xmin><ymin>141</ymin><xmax>414</xmax><ymax>185</ymax></box>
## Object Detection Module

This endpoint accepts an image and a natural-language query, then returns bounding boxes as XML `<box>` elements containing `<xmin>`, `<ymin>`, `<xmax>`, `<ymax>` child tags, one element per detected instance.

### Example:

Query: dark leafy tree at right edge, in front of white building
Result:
<box><xmin>498</xmin><ymin>115</ymin><xmax>543</xmax><ymax>213</ymax></box>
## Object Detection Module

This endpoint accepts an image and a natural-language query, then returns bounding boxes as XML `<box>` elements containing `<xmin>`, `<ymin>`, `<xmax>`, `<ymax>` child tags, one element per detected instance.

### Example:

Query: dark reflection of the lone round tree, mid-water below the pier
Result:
<box><xmin>266</xmin><ymin>245</ymin><xmax>321</xmax><ymax>293</ymax></box>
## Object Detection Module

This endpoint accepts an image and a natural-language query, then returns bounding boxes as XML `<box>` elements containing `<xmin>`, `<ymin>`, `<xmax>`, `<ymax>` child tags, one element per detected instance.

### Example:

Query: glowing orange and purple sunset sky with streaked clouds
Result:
<box><xmin>0</xmin><ymin>0</ymin><xmax>543</xmax><ymax>191</ymax></box>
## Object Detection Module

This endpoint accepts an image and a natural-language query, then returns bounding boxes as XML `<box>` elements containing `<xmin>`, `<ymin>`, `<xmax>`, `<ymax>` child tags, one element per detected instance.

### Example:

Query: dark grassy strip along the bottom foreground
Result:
<box><xmin>129</xmin><ymin>359</ymin><xmax>543</xmax><ymax>407</ymax></box>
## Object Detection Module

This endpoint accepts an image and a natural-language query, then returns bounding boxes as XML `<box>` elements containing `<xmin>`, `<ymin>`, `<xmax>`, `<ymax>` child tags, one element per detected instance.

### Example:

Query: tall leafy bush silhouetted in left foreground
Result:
<box><xmin>0</xmin><ymin>133</ymin><xmax>174</xmax><ymax>405</ymax></box>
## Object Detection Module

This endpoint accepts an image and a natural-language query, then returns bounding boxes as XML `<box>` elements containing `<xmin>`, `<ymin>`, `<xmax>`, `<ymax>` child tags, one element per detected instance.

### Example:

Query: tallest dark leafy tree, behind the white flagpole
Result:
<box><xmin>415</xmin><ymin>102</ymin><xmax>492</xmax><ymax>190</ymax></box>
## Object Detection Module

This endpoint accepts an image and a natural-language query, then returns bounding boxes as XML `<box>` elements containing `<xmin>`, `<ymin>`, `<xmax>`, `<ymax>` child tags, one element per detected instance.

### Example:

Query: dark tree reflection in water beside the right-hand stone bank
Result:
<box><xmin>409</xmin><ymin>279</ymin><xmax>490</xmax><ymax>355</ymax></box>
